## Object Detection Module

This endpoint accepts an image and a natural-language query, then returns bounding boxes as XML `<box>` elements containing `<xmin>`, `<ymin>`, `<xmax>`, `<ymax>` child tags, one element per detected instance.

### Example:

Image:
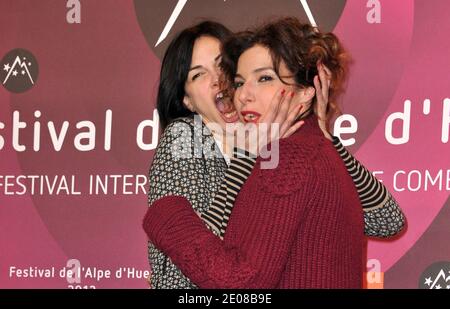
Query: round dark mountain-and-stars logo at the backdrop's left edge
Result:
<box><xmin>0</xmin><ymin>48</ymin><xmax>39</xmax><ymax>93</ymax></box>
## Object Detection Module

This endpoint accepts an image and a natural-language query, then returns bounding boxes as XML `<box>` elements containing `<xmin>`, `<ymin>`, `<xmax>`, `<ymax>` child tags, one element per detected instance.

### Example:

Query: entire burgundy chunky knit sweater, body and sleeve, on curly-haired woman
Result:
<box><xmin>143</xmin><ymin>116</ymin><xmax>364</xmax><ymax>288</ymax></box>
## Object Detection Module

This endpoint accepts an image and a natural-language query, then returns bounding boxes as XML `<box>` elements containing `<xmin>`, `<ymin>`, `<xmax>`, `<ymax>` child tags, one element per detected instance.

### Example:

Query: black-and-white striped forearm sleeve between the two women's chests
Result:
<box><xmin>201</xmin><ymin>148</ymin><xmax>256</xmax><ymax>239</ymax></box>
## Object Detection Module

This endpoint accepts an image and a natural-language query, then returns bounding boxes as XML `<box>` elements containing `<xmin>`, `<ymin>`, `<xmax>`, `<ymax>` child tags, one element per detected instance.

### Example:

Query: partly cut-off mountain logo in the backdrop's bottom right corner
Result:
<box><xmin>419</xmin><ymin>262</ymin><xmax>450</xmax><ymax>290</ymax></box>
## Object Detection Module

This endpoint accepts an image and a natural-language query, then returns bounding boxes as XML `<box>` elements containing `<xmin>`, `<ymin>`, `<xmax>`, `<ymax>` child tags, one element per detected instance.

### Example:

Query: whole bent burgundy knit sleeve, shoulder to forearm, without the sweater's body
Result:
<box><xmin>143</xmin><ymin>140</ymin><xmax>318</xmax><ymax>288</ymax></box>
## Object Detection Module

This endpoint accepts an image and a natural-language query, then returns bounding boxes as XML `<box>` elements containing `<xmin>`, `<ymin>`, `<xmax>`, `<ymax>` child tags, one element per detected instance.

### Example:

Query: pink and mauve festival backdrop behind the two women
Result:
<box><xmin>0</xmin><ymin>0</ymin><xmax>450</xmax><ymax>288</ymax></box>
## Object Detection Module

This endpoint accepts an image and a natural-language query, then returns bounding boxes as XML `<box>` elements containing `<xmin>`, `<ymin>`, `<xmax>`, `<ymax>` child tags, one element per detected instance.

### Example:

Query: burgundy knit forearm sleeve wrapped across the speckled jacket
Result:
<box><xmin>143</xmin><ymin>196</ymin><xmax>259</xmax><ymax>289</ymax></box>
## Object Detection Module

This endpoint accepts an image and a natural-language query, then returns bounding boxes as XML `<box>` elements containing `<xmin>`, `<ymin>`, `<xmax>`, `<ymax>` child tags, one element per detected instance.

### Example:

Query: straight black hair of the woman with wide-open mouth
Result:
<box><xmin>156</xmin><ymin>21</ymin><xmax>232</xmax><ymax>130</ymax></box>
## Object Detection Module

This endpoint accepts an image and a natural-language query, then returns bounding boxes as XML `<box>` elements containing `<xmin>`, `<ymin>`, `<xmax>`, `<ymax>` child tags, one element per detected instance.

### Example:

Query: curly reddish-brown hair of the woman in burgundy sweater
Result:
<box><xmin>221</xmin><ymin>17</ymin><xmax>350</xmax><ymax>119</ymax></box>
